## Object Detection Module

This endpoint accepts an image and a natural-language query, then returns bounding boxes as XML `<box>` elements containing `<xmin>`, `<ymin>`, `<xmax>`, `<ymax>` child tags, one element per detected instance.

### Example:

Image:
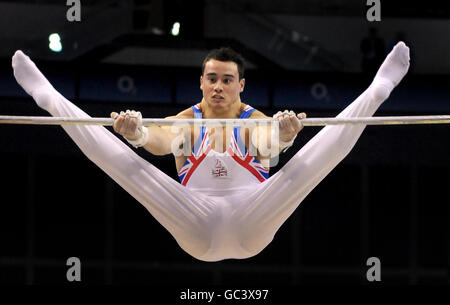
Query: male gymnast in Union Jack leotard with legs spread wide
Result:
<box><xmin>12</xmin><ymin>42</ymin><xmax>409</xmax><ymax>262</ymax></box>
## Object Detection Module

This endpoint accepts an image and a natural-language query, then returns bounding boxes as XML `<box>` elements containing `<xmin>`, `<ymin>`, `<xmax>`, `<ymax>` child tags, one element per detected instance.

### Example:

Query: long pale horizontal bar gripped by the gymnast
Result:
<box><xmin>0</xmin><ymin>115</ymin><xmax>450</xmax><ymax>126</ymax></box>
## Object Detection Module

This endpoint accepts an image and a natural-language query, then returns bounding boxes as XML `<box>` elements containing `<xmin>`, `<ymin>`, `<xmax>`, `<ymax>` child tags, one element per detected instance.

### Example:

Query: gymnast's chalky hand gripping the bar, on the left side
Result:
<box><xmin>111</xmin><ymin>110</ymin><xmax>142</xmax><ymax>141</ymax></box>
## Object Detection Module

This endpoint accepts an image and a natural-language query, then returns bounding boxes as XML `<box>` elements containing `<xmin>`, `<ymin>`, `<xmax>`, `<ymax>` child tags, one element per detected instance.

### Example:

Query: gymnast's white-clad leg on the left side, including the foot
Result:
<box><xmin>12</xmin><ymin>51</ymin><xmax>215</xmax><ymax>257</ymax></box>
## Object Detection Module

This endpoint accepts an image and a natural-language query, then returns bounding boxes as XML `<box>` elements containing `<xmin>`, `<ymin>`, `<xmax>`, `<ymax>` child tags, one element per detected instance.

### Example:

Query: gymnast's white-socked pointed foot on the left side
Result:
<box><xmin>12</xmin><ymin>51</ymin><xmax>59</xmax><ymax>111</ymax></box>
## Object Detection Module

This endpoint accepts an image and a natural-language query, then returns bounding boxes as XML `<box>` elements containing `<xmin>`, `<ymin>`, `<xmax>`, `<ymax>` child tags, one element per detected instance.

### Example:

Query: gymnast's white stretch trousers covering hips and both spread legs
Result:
<box><xmin>29</xmin><ymin>75</ymin><xmax>392</xmax><ymax>261</ymax></box>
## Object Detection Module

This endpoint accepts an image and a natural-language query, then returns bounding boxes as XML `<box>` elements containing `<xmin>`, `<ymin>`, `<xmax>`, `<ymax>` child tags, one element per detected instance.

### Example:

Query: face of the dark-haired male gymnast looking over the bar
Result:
<box><xmin>200</xmin><ymin>59</ymin><xmax>245</xmax><ymax>111</ymax></box>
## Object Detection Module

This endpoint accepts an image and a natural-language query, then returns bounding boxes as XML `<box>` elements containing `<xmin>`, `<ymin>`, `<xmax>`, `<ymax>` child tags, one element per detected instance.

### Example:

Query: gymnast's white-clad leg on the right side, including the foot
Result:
<box><xmin>234</xmin><ymin>42</ymin><xmax>409</xmax><ymax>254</ymax></box>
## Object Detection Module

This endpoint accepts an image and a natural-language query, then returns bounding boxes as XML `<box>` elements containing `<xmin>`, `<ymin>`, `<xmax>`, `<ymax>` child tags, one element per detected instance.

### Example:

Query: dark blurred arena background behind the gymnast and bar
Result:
<box><xmin>0</xmin><ymin>0</ymin><xmax>450</xmax><ymax>286</ymax></box>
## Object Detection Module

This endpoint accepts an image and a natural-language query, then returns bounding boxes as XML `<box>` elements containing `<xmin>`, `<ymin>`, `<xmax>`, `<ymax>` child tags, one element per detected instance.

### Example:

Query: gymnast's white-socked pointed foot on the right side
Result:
<box><xmin>373</xmin><ymin>41</ymin><xmax>409</xmax><ymax>100</ymax></box>
